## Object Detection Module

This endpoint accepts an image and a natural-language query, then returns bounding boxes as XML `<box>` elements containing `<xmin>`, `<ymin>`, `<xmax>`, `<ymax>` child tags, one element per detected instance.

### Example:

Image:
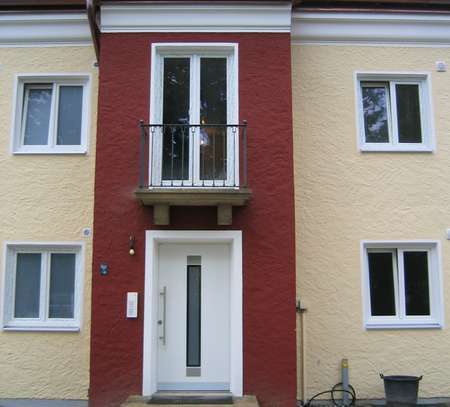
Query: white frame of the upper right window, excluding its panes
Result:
<box><xmin>355</xmin><ymin>72</ymin><xmax>436</xmax><ymax>152</ymax></box>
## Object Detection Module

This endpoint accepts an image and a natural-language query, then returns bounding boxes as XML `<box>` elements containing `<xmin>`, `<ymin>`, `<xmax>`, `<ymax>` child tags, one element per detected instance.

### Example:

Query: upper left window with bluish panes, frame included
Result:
<box><xmin>13</xmin><ymin>76</ymin><xmax>89</xmax><ymax>154</ymax></box>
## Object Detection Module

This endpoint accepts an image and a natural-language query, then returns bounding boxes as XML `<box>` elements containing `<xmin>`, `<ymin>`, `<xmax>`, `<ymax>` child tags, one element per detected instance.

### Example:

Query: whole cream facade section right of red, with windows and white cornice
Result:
<box><xmin>292</xmin><ymin>8</ymin><xmax>450</xmax><ymax>399</ymax></box>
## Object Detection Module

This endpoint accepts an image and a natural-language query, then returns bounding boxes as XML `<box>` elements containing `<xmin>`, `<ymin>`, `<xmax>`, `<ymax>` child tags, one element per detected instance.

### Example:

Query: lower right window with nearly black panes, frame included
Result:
<box><xmin>363</xmin><ymin>242</ymin><xmax>442</xmax><ymax>328</ymax></box>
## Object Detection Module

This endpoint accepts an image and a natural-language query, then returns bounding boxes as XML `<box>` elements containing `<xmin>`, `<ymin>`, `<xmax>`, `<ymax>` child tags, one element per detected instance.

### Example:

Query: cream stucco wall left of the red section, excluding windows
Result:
<box><xmin>0</xmin><ymin>47</ymin><xmax>97</xmax><ymax>399</ymax></box>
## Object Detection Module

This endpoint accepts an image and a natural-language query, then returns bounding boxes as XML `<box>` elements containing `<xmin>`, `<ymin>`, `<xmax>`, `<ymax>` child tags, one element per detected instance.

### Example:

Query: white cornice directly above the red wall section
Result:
<box><xmin>101</xmin><ymin>1</ymin><xmax>291</xmax><ymax>33</ymax></box>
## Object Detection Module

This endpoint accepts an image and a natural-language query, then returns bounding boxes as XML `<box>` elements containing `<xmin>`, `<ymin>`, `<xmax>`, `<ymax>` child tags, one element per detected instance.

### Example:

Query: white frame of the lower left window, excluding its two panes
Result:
<box><xmin>1</xmin><ymin>242</ymin><xmax>85</xmax><ymax>332</ymax></box>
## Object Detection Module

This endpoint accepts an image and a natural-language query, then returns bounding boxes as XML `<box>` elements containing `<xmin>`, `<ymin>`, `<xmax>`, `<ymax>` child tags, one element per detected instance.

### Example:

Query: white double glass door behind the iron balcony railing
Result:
<box><xmin>150</xmin><ymin>44</ymin><xmax>239</xmax><ymax>187</ymax></box>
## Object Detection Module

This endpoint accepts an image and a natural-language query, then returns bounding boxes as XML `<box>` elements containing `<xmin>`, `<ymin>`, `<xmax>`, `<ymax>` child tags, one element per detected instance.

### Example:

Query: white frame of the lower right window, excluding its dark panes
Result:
<box><xmin>361</xmin><ymin>240</ymin><xmax>444</xmax><ymax>329</ymax></box>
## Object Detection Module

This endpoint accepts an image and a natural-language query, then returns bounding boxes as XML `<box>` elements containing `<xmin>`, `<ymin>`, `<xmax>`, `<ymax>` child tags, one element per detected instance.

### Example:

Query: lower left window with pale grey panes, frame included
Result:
<box><xmin>4</xmin><ymin>244</ymin><xmax>82</xmax><ymax>330</ymax></box>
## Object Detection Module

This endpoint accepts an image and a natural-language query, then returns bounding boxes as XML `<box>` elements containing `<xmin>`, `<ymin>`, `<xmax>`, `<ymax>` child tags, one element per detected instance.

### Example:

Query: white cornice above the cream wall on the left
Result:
<box><xmin>0</xmin><ymin>13</ymin><xmax>91</xmax><ymax>47</ymax></box>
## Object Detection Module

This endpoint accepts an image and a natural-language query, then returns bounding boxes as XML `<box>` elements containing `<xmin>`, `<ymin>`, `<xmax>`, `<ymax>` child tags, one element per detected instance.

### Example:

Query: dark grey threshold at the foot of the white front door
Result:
<box><xmin>148</xmin><ymin>391</ymin><xmax>233</xmax><ymax>404</ymax></box>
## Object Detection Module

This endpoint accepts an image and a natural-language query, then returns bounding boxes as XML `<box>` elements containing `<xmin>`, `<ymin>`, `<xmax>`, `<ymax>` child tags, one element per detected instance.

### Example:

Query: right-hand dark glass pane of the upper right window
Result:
<box><xmin>395</xmin><ymin>84</ymin><xmax>422</xmax><ymax>143</ymax></box>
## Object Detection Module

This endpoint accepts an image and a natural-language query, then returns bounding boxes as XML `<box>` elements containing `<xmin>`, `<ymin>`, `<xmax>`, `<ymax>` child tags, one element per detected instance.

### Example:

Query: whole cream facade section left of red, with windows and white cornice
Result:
<box><xmin>0</xmin><ymin>5</ymin><xmax>97</xmax><ymax>400</ymax></box>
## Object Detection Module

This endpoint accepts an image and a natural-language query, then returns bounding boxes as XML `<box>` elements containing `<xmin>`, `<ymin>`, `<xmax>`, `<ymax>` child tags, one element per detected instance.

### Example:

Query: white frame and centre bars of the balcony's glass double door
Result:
<box><xmin>148</xmin><ymin>43</ymin><xmax>239</xmax><ymax>187</ymax></box>
